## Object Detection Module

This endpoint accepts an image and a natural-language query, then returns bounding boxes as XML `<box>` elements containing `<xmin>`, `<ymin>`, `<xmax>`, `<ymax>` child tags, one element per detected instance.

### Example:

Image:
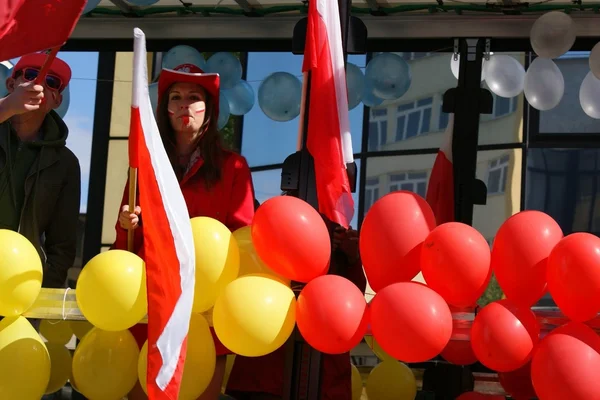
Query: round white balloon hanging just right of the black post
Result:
<box><xmin>483</xmin><ymin>54</ymin><xmax>525</xmax><ymax>98</ymax></box>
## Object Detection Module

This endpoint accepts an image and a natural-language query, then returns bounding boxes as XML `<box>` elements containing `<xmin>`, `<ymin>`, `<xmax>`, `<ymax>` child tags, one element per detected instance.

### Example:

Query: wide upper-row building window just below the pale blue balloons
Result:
<box><xmin>396</xmin><ymin>97</ymin><xmax>433</xmax><ymax>141</ymax></box>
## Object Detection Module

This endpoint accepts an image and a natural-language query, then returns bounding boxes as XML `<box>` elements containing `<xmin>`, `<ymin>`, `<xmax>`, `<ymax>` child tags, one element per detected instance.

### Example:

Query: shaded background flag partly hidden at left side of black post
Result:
<box><xmin>426</xmin><ymin>114</ymin><xmax>454</xmax><ymax>225</ymax></box>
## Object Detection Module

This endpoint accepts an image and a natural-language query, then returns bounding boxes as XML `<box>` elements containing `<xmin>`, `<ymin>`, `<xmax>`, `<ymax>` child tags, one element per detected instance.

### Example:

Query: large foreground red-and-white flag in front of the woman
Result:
<box><xmin>129</xmin><ymin>28</ymin><xmax>195</xmax><ymax>400</ymax></box>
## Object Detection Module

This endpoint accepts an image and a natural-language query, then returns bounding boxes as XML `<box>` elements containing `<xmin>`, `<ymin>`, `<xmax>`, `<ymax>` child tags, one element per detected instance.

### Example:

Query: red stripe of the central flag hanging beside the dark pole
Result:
<box><xmin>302</xmin><ymin>1</ymin><xmax>354</xmax><ymax>227</ymax></box>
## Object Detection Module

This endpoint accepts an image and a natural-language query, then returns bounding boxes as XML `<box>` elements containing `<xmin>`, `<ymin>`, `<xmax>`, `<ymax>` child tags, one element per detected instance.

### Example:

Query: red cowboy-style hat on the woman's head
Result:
<box><xmin>158</xmin><ymin>64</ymin><xmax>220</xmax><ymax>115</ymax></box>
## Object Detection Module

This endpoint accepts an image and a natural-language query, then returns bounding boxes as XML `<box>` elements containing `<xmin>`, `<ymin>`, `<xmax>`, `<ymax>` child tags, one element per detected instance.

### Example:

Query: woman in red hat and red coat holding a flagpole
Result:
<box><xmin>113</xmin><ymin>64</ymin><xmax>254</xmax><ymax>400</ymax></box>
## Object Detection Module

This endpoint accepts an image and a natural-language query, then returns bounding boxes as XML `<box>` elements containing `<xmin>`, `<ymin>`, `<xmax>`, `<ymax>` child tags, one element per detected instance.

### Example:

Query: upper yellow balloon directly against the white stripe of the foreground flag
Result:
<box><xmin>192</xmin><ymin>217</ymin><xmax>240</xmax><ymax>313</ymax></box>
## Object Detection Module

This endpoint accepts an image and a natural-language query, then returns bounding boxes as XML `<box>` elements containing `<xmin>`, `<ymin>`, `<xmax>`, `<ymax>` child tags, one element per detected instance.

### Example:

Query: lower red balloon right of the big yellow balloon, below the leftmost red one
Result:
<box><xmin>296</xmin><ymin>275</ymin><xmax>368</xmax><ymax>354</ymax></box>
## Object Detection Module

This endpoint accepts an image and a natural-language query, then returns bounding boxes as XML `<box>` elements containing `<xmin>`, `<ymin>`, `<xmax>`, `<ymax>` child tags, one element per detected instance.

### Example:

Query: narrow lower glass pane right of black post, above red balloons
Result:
<box><xmin>473</xmin><ymin>149</ymin><xmax>522</xmax><ymax>305</ymax></box>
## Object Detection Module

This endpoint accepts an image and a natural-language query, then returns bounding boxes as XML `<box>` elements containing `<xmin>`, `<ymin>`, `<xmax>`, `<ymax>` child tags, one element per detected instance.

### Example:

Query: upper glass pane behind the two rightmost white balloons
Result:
<box><xmin>540</xmin><ymin>52</ymin><xmax>600</xmax><ymax>134</ymax></box>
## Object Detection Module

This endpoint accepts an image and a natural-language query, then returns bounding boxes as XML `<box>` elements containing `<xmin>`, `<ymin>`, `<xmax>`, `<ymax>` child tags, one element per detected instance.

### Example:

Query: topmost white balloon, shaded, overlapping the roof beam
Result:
<box><xmin>529</xmin><ymin>11</ymin><xmax>577</xmax><ymax>59</ymax></box>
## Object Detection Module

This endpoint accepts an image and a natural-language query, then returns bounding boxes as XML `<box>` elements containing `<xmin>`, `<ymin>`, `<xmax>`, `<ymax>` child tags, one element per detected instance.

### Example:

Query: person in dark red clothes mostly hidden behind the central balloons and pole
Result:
<box><xmin>227</xmin><ymin>209</ymin><xmax>367</xmax><ymax>400</ymax></box>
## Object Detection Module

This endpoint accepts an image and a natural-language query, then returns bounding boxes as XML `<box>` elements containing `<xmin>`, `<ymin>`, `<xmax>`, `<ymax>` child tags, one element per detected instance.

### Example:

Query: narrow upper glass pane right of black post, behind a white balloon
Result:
<box><xmin>479</xmin><ymin>53</ymin><xmax>525</xmax><ymax>144</ymax></box>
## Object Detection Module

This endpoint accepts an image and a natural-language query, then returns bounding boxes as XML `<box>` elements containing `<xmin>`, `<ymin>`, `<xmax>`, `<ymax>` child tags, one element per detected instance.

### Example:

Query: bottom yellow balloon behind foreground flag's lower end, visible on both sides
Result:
<box><xmin>138</xmin><ymin>314</ymin><xmax>217</xmax><ymax>400</ymax></box>
